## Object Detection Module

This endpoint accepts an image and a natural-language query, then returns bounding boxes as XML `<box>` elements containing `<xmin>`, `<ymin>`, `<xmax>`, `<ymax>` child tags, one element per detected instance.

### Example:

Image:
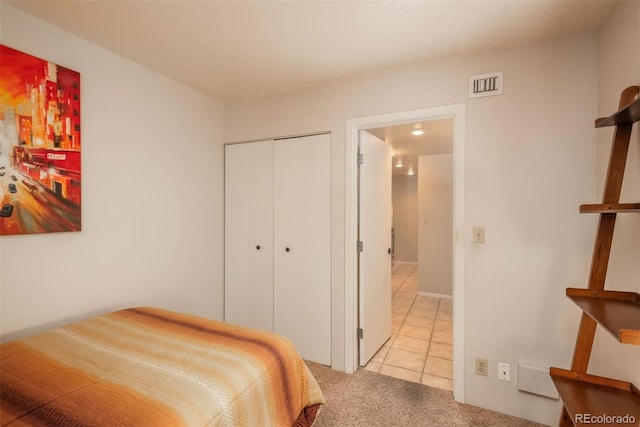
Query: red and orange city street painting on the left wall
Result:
<box><xmin>0</xmin><ymin>45</ymin><xmax>81</xmax><ymax>235</ymax></box>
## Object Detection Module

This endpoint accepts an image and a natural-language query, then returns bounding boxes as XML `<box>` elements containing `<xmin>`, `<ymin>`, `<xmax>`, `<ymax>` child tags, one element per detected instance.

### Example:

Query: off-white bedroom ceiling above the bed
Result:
<box><xmin>6</xmin><ymin>0</ymin><xmax>615</xmax><ymax>102</ymax></box>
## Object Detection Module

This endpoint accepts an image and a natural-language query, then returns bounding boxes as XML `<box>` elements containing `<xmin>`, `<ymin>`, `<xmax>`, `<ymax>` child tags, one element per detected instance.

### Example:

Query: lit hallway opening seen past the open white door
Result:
<box><xmin>359</xmin><ymin>118</ymin><xmax>453</xmax><ymax>390</ymax></box>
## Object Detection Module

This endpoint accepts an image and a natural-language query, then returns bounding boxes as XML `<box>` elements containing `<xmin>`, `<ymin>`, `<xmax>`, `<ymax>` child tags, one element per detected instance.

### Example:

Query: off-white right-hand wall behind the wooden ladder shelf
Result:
<box><xmin>585</xmin><ymin>1</ymin><xmax>640</xmax><ymax>386</ymax></box>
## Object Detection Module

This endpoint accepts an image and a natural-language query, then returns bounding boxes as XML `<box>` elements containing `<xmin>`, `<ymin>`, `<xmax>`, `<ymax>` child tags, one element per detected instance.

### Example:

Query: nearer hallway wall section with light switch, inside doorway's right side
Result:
<box><xmin>418</xmin><ymin>154</ymin><xmax>454</xmax><ymax>296</ymax></box>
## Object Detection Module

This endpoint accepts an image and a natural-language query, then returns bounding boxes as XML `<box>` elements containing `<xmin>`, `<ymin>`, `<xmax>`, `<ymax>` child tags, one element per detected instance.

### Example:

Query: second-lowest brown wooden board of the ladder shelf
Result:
<box><xmin>567</xmin><ymin>288</ymin><xmax>640</xmax><ymax>345</ymax></box>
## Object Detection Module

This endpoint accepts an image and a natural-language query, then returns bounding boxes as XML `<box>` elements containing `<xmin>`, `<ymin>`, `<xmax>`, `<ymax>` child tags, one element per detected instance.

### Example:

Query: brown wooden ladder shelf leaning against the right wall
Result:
<box><xmin>550</xmin><ymin>86</ymin><xmax>640</xmax><ymax>427</ymax></box>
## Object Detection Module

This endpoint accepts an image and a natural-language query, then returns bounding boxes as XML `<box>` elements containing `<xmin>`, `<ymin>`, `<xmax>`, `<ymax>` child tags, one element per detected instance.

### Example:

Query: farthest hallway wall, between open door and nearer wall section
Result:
<box><xmin>391</xmin><ymin>175</ymin><xmax>418</xmax><ymax>263</ymax></box>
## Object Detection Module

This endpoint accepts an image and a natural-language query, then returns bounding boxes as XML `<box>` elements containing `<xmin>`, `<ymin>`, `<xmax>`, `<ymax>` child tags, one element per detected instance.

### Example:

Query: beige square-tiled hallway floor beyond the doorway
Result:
<box><xmin>365</xmin><ymin>262</ymin><xmax>453</xmax><ymax>390</ymax></box>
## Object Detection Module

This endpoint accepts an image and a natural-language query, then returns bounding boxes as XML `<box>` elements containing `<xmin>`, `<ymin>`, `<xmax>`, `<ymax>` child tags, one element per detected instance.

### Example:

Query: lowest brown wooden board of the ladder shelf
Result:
<box><xmin>549</xmin><ymin>368</ymin><xmax>640</xmax><ymax>426</ymax></box>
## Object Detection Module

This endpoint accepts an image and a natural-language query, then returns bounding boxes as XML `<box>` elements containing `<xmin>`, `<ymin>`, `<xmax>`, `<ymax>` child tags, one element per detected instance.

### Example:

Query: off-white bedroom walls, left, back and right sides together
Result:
<box><xmin>0</xmin><ymin>2</ymin><xmax>640</xmax><ymax>424</ymax></box>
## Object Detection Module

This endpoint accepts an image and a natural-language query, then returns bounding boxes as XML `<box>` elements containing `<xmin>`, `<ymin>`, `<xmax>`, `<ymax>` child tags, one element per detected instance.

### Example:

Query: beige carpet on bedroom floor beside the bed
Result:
<box><xmin>307</xmin><ymin>362</ymin><xmax>541</xmax><ymax>427</ymax></box>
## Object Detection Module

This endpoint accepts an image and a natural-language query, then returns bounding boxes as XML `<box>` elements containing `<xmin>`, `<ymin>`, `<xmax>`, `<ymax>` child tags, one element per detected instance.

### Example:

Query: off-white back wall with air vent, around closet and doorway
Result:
<box><xmin>224</xmin><ymin>32</ymin><xmax>598</xmax><ymax>424</ymax></box>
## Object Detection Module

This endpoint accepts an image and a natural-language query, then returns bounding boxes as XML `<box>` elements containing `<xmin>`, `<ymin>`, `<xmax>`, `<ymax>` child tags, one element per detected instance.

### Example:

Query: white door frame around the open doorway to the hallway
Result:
<box><xmin>344</xmin><ymin>104</ymin><xmax>465</xmax><ymax>403</ymax></box>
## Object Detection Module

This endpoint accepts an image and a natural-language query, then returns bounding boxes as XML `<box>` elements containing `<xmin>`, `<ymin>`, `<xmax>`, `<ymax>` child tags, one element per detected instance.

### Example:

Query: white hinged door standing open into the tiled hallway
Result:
<box><xmin>358</xmin><ymin>131</ymin><xmax>392</xmax><ymax>366</ymax></box>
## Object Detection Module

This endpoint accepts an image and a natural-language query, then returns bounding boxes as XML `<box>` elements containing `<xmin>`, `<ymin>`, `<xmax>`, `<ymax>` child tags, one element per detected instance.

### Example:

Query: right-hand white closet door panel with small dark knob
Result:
<box><xmin>273</xmin><ymin>135</ymin><xmax>331</xmax><ymax>365</ymax></box>
